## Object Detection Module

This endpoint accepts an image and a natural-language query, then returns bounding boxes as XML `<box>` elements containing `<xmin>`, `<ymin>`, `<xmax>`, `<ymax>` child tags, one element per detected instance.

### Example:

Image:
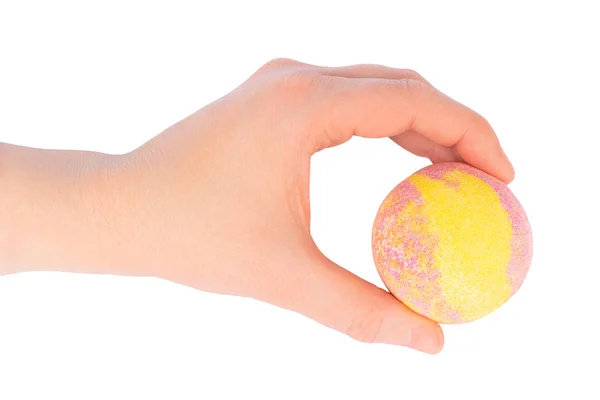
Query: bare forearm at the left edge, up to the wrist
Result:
<box><xmin>0</xmin><ymin>143</ymin><xmax>136</xmax><ymax>274</ymax></box>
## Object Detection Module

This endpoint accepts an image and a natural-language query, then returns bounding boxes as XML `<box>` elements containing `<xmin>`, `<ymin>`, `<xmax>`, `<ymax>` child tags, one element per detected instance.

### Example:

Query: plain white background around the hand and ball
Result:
<box><xmin>0</xmin><ymin>0</ymin><xmax>600</xmax><ymax>400</ymax></box>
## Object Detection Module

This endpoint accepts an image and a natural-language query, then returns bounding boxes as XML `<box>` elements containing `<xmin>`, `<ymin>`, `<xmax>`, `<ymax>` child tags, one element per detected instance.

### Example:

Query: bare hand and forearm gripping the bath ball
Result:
<box><xmin>0</xmin><ymin>59</ymin><xmax>514</xmax><ymax>353</ymax></box>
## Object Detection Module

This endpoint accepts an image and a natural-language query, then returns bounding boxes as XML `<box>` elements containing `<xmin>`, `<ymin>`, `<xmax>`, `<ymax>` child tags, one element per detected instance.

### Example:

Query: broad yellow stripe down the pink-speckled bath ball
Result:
<box><xmin>409</xmin><ymin>169</ymin><xmax>512</xmax><ymax>321</ymax></box>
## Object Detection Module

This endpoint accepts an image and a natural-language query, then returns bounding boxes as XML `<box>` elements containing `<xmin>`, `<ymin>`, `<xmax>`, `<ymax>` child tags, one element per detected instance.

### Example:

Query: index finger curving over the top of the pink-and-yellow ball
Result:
<box><xmin>315</xmin><ymin>78</ymin><xmax>514</xmax><ymax>182</ymax></box>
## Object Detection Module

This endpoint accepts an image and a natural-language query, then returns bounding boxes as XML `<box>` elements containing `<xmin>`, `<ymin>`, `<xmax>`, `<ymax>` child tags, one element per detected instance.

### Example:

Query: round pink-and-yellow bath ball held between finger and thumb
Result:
<box><xmin>372</xmin><ymin>163</ymin><xmax>532</xmax><ymax>324</ymax></box>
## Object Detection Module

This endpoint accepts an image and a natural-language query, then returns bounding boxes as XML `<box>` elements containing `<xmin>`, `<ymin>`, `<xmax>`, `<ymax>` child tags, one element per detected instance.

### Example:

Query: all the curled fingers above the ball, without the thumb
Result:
<box><xmin>255</xmin><ymin>59</ymin><xmax>514</xmax><ymax>183</ymax></box>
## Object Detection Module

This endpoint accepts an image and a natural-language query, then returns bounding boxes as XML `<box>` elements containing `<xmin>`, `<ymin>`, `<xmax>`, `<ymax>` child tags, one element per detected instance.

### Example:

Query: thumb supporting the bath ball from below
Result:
<box><xmin>280</xmin><ymin>256</ymin><xmax>444</xmax><ymax>354</ymax></box>
